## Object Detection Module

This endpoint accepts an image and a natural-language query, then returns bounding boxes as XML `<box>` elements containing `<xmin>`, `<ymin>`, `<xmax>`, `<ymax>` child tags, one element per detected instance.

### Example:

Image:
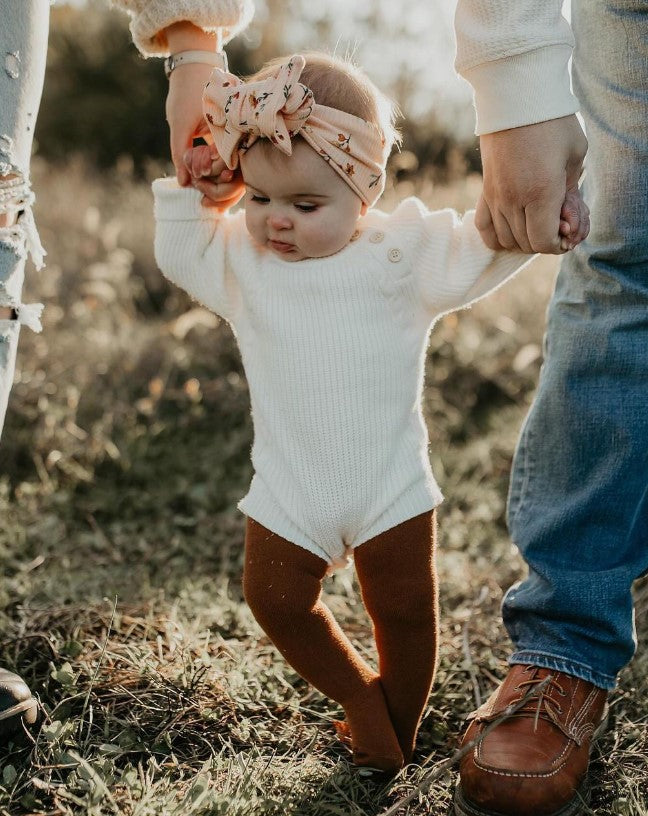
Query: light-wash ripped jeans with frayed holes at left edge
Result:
<box><xmin>0</xmin><ymin>0</ymin><xmax>50</xmax><ymax>432</ymax></box>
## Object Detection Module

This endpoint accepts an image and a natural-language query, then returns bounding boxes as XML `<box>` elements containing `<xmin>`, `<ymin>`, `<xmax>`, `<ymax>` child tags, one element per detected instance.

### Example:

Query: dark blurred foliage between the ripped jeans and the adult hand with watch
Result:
<box><xmin>36</xmin><ymin>4</ymin><xmax>168</xmax><ymax>169</ymax></box>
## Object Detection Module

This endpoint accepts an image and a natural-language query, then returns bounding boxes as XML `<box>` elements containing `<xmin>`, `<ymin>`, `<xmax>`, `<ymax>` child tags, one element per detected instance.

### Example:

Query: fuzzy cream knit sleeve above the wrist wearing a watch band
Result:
<box><xmin>111</xmin><ymin>0</ymin><xmax>254</xmax><ymax>57</ymax></box>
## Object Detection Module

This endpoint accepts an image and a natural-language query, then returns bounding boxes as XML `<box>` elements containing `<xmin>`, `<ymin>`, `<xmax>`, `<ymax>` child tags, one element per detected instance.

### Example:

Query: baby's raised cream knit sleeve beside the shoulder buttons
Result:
<box><xmin>389</xmin><ymin>198</ymin><xmax>534</xmax><ymax>319</ymax></box>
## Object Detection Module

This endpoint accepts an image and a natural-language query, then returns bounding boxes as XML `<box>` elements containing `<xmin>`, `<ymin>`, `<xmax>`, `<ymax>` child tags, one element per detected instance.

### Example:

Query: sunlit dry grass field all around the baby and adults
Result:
<box><xmin>0</xmin><ymin>156</ymin><xmax>648</xmax><ymax>816</ymax></box>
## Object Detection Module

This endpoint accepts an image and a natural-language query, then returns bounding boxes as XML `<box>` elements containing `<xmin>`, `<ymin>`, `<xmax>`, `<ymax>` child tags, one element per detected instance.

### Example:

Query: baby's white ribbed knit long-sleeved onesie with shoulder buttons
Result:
<box><xmin>153</xmin><ymin>179</ymin><xmax>529</xmax><ymax>570</ymax></box>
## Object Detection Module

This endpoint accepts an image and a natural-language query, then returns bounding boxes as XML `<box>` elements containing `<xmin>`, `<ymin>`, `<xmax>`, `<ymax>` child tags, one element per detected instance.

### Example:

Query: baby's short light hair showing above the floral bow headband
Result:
<box><xmin>247</xmin><ymin>51</ymin><xmax>400</xmax><ymax>154</ymax></box>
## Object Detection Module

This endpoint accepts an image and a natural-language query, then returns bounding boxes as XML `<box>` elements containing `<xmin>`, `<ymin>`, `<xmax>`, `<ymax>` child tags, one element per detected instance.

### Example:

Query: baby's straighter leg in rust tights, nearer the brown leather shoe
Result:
<box><xmin>354</xmin><ymin>510</ymin><xmax>438</xmax><ymax>762</ymax></box>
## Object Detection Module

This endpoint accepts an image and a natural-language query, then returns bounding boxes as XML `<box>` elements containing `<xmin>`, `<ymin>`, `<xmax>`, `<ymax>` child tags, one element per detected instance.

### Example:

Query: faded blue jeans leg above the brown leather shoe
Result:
<box><xmin>502</xmin><ymin>0</ymin><xmax>648</xmax><ymax>689</ymax></box>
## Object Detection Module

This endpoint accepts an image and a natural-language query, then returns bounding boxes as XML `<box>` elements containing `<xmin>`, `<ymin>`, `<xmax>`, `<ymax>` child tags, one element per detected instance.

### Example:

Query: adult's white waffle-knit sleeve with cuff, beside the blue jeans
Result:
<box><xmin>455</xmin><ymin>0</ymin><xmax>578</xmax><ymax>135</ymax></box>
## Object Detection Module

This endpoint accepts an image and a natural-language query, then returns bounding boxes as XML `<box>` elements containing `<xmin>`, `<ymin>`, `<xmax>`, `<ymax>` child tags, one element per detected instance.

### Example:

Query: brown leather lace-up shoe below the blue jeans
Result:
<box><xmin>454</xmin><ymin>665</ymin><xmax>607</xmax><ymax>816</ymax></box>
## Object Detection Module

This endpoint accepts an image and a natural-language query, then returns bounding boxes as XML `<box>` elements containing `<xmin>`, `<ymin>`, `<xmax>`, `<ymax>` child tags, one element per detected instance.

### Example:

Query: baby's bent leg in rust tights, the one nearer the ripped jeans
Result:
<box><xmin>243</xmin><ymin>519</ymin><xmax>403</xmax><ymax>771</ymax></box>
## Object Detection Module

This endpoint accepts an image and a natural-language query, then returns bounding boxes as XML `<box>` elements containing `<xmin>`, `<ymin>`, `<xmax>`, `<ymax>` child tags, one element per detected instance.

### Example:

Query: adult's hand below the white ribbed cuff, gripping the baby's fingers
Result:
<box><xmin>475</xmin><ymin>115</ymin><xmax>589</xmax><ymax>254</ymax></box>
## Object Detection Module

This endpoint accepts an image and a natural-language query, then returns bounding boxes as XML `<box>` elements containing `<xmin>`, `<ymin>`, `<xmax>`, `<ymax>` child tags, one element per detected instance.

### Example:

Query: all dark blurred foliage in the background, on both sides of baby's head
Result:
<box><xmin>36</xmin><ymin>0</ymin><xmax>480</xmax><ymax>182</ymax></box>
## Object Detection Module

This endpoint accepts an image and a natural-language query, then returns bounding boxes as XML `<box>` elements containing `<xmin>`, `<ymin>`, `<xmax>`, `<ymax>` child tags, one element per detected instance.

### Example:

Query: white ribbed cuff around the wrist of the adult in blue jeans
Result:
<box><xmin>462</xmin><ymin>45</ymin><xmax>578</xmax><ymax>136</ymax></box>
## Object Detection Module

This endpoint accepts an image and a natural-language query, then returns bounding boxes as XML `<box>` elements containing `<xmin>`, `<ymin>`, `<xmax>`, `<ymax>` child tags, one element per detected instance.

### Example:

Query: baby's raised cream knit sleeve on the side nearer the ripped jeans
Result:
<box><xmin>153</xmin><ymin>178</ymin><xmax>245</xmax><ymax>322</ymax></box>
